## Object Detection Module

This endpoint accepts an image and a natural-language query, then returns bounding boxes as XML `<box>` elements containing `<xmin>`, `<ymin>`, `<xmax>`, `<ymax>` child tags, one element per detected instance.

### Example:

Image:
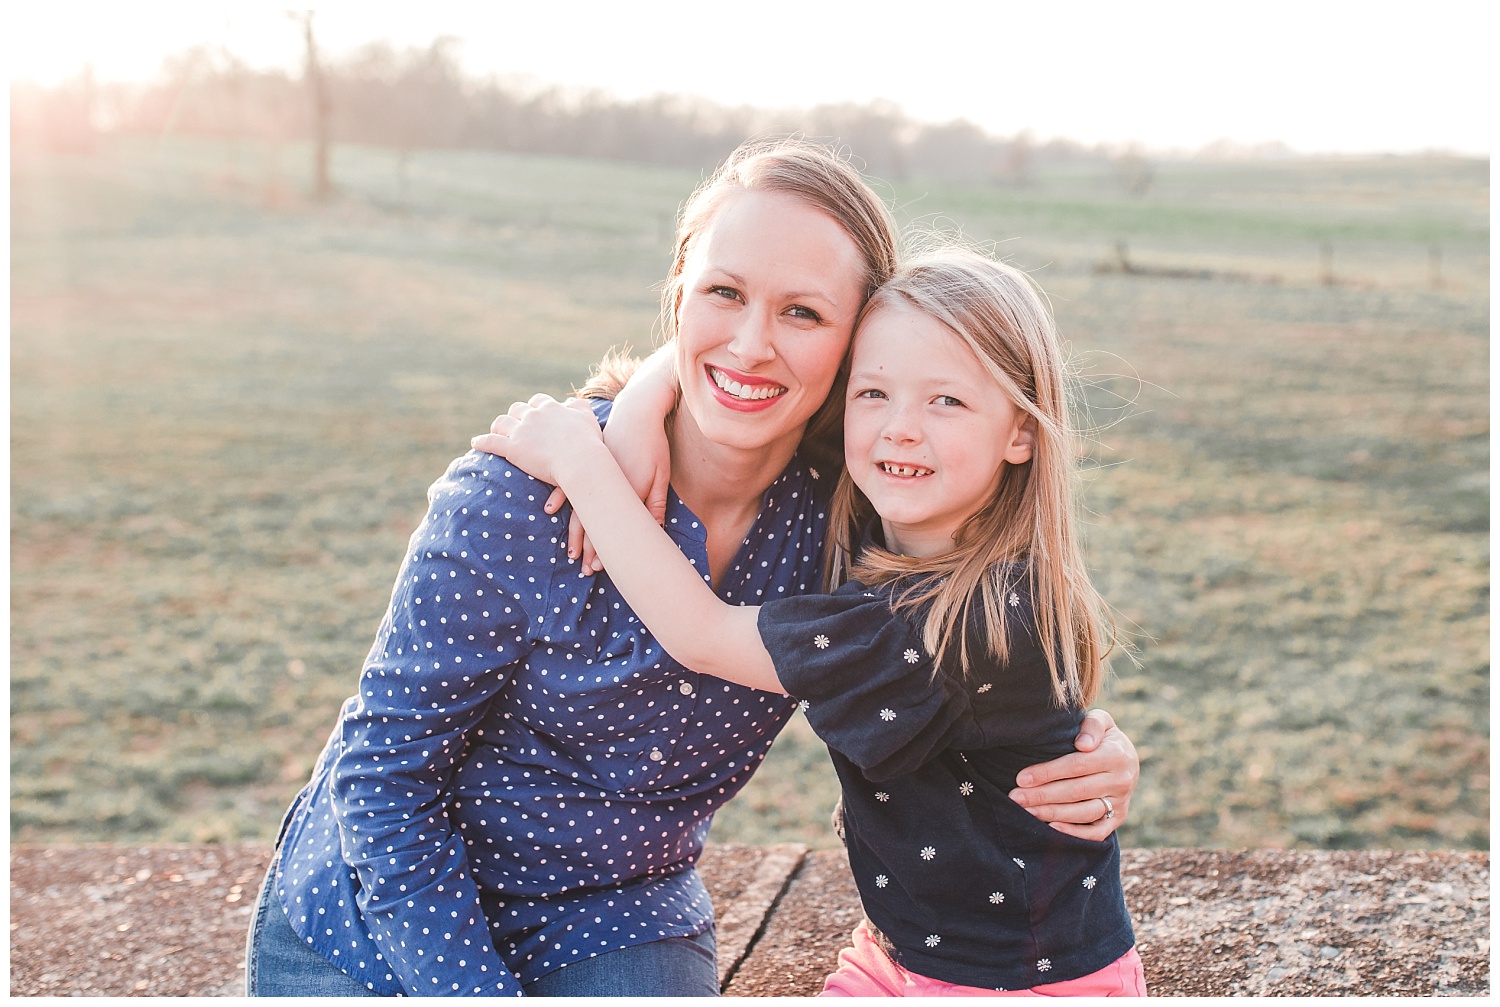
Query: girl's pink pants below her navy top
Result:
<box><xmin>819</xmin><ymin>923</ymin><xmax>1146</xmax><ymax>996</ymax></box>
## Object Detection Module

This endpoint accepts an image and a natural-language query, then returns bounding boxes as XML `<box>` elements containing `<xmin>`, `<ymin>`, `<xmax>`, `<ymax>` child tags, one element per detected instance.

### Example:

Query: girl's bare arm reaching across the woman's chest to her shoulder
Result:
<box><xmin>474</xmin><ymin>395</ymin><xmax>786</xmax><ymax>693</ymax></box>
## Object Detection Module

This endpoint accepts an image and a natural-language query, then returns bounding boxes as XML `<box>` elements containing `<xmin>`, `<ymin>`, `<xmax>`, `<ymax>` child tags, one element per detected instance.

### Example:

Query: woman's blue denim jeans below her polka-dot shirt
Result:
<box><xmin>245</xmin><ymin>860</ymin><xmax>719</xmax><ymax>996</ymax></box>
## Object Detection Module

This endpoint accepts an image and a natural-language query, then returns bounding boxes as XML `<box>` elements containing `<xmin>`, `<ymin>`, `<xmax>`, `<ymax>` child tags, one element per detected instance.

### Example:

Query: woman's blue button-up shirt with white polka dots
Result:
<box><xmin>276</xmin><ymin>408</ymin><xmax>827</xmax><ymax>995</ymax></box>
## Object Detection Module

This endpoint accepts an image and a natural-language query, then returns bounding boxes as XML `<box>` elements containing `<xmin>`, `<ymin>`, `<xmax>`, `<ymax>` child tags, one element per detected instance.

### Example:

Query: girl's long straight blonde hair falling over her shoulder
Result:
<box><xmin>830</xmin><ymin>248</ymin><xmax>1113</xmax><ymax>707</ymax></box>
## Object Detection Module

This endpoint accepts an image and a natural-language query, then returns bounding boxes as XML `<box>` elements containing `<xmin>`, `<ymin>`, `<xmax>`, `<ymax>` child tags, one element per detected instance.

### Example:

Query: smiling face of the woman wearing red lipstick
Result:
<box><xmin>677</xmin><ymin>191</ymin><xmax>866</xmax><ymax>456</ymax></box>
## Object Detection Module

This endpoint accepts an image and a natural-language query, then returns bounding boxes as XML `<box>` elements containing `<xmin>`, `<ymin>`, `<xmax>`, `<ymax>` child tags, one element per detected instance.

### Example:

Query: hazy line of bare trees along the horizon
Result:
<box><xmin>11</xmin><ymin>39</ymin><xmax>1109</xmax><ymax>183</ymax></box>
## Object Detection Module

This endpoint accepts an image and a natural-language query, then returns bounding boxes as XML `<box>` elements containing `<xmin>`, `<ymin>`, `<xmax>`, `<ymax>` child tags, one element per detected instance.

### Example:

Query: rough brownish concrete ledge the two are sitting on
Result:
<box><xmin>11</xmin><ymin>845</ymin><xmax>1490</xmax><ymax>996</ymax></box>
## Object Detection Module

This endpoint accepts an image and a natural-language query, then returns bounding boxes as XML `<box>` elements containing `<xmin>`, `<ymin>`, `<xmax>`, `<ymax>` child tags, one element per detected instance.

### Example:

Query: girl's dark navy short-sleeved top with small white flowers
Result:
<box><xmin>759</xmin><ymin>570</ymin><xmax>1136</xmax><ymax>990</ymax></box>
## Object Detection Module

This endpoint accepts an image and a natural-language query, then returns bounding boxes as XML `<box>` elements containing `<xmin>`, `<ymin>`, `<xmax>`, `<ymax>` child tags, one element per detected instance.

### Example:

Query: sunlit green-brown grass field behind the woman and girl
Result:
<box><xmin>11</xmin><ymin>140</ymin><xmax>1490</xmax><ymax>848</ymax></box>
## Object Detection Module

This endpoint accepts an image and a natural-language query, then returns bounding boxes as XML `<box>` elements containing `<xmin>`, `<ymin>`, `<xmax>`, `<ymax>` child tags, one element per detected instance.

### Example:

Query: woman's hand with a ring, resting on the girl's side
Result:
<box><xmin>1011</xmin><ymin>710</ymin><xmax>1140</xmax><ymax>840</ymax></box>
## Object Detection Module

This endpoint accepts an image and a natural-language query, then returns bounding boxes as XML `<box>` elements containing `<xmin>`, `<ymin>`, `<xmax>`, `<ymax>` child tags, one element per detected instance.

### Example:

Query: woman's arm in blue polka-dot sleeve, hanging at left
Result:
<box><xmin>330</xmin><ymin>455</ymin><xmax>563</xmax><ymax>995</ymax></box>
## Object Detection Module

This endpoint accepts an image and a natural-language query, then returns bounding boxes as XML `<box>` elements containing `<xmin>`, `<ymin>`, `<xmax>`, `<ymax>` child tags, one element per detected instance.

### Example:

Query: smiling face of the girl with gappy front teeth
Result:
<box><xmin>845</xmin><ymin>302</ymin><xmax>1035</xmax><ymax>558</ymax></box>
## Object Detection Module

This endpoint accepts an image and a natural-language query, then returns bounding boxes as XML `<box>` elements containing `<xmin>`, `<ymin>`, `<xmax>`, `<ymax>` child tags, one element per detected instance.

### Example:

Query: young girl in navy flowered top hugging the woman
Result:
<box><xmin>495</xmin><ymin>251</ymin><xmax>1145</xmax><ymax>996</ymax></box>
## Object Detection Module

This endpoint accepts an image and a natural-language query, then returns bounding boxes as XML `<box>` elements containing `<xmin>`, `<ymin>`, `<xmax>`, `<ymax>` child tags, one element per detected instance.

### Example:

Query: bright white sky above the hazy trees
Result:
<box><xmin>5</xmin><ymin>0</ymin><xmax>1500</xmax><ymax>155</ymax></box>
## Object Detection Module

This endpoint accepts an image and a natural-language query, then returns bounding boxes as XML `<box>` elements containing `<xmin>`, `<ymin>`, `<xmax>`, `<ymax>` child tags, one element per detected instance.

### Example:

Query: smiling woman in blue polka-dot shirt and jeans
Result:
<box><xmin>246</xmin><ymin>143</ymin><xmax>1136</xmax><ymax>995</ymax></box>
